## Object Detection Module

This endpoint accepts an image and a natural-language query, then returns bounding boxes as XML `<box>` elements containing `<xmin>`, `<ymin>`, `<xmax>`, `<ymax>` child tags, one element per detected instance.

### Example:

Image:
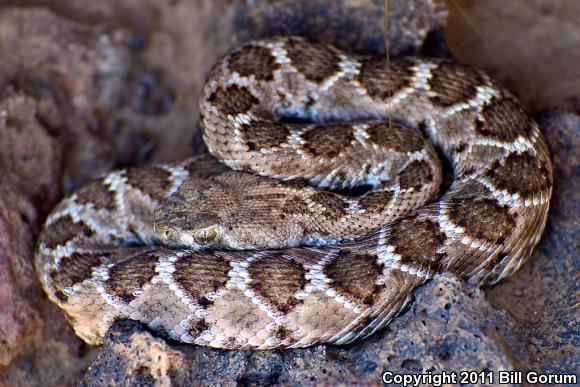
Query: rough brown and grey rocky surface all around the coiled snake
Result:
<box><xmin>0</xmin><ymin>0</ymin><xmax>580</xmax><ymax>386</ymax></box>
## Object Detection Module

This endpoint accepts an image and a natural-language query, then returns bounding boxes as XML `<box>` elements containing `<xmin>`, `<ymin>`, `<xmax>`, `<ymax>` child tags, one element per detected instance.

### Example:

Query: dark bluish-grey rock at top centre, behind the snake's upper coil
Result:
<box><xmin>234</xmin><ymin>0</ymin><xmax>447</xmax><ymax>56</ymax></box>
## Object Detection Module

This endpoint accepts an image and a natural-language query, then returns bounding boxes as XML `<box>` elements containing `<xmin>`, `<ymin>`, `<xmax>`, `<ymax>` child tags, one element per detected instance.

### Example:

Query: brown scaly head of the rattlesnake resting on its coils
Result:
<box><xmin>153</xmin><ymin>172</ymin><xmax>303</xmax><ymax>250</ymax></box>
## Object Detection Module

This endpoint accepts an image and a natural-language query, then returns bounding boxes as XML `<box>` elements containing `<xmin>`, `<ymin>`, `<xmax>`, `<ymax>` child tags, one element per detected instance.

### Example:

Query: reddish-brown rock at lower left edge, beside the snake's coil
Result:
<box><xmin>0</xmin><ymin>178</ymin><xmax>92</xmax><ymax>386</ymax></box>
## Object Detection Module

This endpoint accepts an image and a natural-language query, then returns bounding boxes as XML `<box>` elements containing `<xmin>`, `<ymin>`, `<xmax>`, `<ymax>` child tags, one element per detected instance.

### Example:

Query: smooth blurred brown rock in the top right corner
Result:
<box><xmin>445</xmin><ymin>0</ymin><xmax>580</xmax><ymax>112</ymax></box>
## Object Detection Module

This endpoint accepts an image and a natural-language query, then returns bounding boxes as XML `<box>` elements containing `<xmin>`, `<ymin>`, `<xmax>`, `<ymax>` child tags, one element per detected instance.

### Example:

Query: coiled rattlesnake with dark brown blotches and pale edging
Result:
<box><xmin>36</xmin><ymin>38</ymin><xmax>552</xmax><ymax>349</ymax></box>
